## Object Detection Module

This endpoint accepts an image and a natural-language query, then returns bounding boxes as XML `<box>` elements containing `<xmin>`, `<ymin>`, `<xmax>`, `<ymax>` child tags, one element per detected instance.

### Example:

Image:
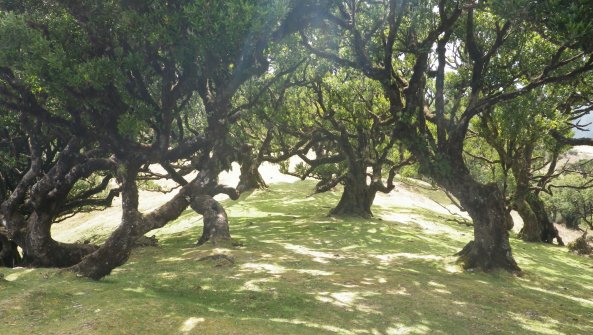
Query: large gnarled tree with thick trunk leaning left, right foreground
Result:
<box><xmin>303</xmin><ymin>0</ymin><xmax>593</xmax><ymax>271</ymax></box>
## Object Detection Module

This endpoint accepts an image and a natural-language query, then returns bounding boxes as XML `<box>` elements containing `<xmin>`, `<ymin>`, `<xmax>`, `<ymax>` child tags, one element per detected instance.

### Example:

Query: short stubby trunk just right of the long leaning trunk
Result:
<box><xmin>191</xmin><ymin>195</ymin><xmax>231</xmax><ymax>245</ymax></box>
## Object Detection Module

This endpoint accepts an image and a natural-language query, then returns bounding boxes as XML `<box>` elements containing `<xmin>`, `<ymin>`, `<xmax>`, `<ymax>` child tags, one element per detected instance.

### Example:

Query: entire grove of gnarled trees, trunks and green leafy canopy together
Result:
<box><xmin>0</xmin><ymin>0</ymin><xmax>593</xmax><ymax>279</ymax></box>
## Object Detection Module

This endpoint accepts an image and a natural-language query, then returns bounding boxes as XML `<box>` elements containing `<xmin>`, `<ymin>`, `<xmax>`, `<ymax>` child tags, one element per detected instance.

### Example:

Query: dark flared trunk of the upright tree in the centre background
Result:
<box><xmin>330</xmin><ymin>175</ymin><xmax>376</xmax><ymax>218</ymax></box>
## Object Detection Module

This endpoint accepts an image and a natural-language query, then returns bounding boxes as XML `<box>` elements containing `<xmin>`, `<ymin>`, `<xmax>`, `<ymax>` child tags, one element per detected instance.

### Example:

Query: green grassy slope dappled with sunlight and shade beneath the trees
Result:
<box><xmin>0</xmin><ymin>182</ymin><xmax>593</xmax><ymax>335</ymax></box>
